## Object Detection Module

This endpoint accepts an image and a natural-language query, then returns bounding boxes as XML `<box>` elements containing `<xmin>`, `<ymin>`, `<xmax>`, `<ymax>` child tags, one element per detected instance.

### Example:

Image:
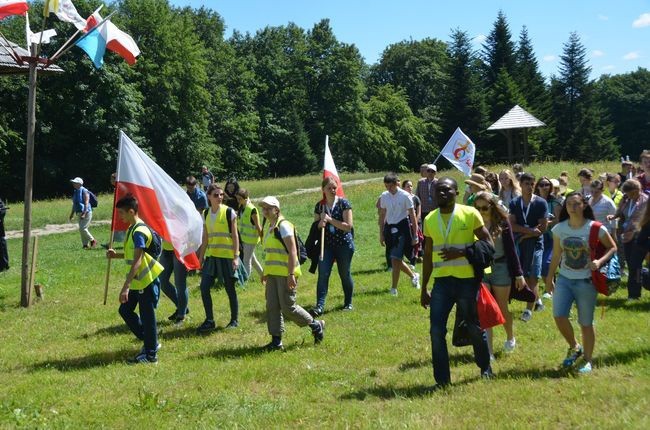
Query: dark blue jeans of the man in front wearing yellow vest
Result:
<box><xmin>429</xmin><ymin>276</ymin><xmax>490</xmax><ymax>385</ymax></box>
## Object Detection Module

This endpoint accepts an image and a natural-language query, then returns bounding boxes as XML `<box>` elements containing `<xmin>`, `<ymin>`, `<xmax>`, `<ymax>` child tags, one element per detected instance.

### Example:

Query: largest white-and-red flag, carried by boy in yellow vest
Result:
<box><xmin>111</xmin><ymin>131</ymin><xmax>203</xmax><ymax>270</ymax></box>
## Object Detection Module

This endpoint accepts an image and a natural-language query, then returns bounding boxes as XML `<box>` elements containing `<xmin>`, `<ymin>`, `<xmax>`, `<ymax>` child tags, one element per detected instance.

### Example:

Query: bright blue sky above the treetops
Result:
<box><xmin>171</xmin><ymin>0</ymin><xmax>650</xmax><ymax>78</ymax></box>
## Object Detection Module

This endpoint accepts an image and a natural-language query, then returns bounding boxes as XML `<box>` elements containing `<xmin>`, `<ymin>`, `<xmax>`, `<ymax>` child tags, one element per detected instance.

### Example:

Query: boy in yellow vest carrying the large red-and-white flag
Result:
<box><xmin>106</xmin><ymin>195</ymin><xmax>163</xmax><ymax>363</ymax></box>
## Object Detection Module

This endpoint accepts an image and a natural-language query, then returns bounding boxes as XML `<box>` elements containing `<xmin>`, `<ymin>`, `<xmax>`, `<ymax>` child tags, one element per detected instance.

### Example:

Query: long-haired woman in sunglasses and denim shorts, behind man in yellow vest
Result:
<box><xmin>474</xmin><ymin>191</ymin><xmax>526</xmax><ymax>358</ymax></box>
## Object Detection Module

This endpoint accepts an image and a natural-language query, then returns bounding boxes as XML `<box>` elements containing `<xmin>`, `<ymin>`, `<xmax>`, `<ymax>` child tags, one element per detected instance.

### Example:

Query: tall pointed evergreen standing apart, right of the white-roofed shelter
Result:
<box><xmin>551</xmin><ymin>32</ymin><xmax>619</xmax><ymax>161</ymax></box>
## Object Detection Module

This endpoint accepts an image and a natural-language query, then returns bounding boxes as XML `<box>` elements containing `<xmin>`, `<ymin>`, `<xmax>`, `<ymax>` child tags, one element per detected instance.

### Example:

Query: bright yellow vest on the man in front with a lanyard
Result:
<box><xmin>424</xmin><ymin>203</ymin><xmax>481</xmax><ymax>278</ymax></box>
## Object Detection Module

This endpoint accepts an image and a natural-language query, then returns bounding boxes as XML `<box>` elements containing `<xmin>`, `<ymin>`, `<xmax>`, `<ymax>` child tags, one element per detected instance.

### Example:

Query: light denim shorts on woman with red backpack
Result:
<box><xmin>553</xmin><ymin>274</ymin><xmax>598</xmax><ymax>326</ymax></box>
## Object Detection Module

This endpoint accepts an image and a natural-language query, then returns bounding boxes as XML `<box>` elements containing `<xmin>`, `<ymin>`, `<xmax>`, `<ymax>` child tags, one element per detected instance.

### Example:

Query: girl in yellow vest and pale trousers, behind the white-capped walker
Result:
<box><xmin>235</xmin><ymin>188</ymin><xmax>263</xmax><ymax>279</ymax></box>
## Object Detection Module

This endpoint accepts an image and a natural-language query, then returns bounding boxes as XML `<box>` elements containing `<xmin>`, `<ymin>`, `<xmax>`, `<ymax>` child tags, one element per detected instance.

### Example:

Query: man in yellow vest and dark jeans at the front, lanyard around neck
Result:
<box><xmin>420</xmin><ymin>178</ymin><xmax>493</xmax><ymax>389</ymax></box>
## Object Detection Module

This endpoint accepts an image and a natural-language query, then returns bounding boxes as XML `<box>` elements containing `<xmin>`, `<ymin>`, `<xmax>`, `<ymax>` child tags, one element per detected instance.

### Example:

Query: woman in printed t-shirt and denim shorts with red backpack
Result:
<box><xmin>546</xmin><ymin>192</ymin><xmax>616</xmax><ymax>373</ymax></box>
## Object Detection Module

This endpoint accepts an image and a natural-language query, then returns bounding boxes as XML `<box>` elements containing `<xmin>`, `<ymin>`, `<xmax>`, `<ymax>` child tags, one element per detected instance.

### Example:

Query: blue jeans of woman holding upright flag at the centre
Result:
<box><xmin>316</xmin><ymin>245</ymin><xmax>354</xmax><ymax>308</ymax></box>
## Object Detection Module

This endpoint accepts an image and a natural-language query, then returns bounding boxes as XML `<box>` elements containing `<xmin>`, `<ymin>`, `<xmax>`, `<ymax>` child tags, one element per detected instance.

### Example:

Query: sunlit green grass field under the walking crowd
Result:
<box><xmin>0</xmin><ymin>163</ymin><xmax>650</xmax><ymax>429</ymax></box>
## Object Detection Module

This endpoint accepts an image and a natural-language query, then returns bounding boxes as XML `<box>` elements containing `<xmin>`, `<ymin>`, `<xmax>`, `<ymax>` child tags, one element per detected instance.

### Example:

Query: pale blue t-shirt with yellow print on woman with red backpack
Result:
<box><xmin>551</xmin><ymin>220</ymin><xmax>607</xmax><ymax>279</ymax></box>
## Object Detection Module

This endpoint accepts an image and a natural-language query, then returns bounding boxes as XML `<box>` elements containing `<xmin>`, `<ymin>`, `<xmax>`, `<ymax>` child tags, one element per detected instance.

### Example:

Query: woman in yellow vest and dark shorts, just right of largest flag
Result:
<box><xmin>197</xmin><ymin>184</ymin><xmax>240</xmax><ymax>333</ymax></box>
